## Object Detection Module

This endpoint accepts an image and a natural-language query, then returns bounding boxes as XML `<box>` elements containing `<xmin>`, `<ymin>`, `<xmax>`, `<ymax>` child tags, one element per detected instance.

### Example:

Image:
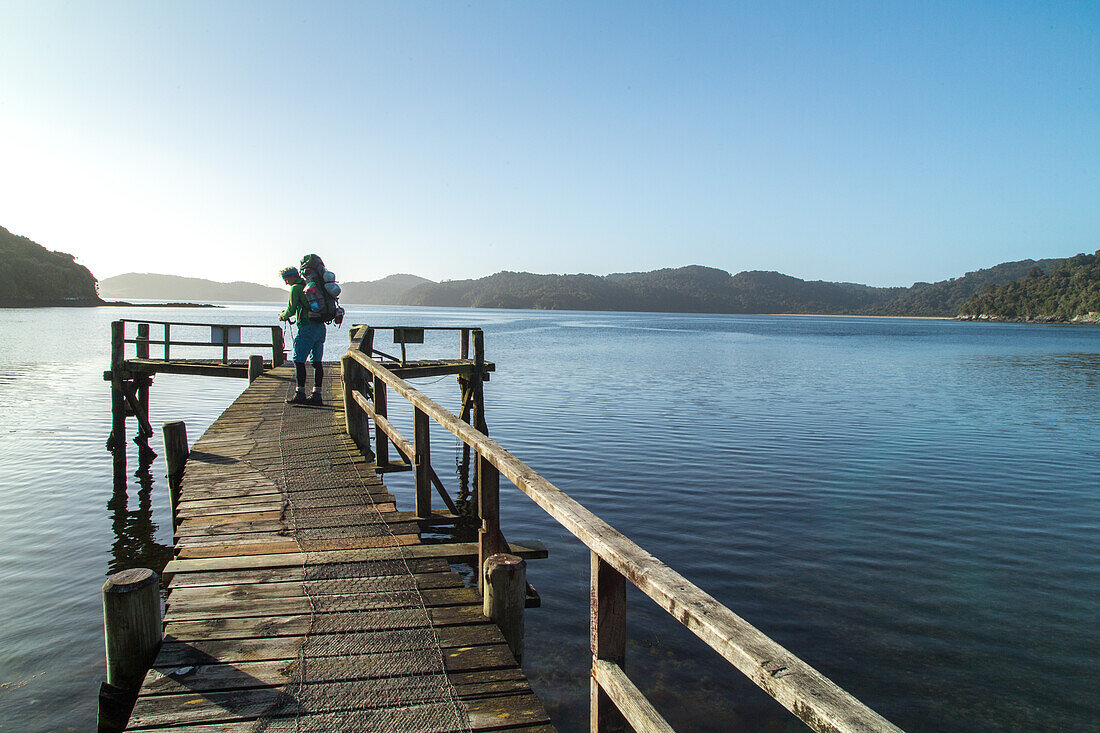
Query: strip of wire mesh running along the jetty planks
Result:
<box><xmin>247</xmin><ymin>378</ymin><xmax>470</xmax><ymax>733</ymax></box>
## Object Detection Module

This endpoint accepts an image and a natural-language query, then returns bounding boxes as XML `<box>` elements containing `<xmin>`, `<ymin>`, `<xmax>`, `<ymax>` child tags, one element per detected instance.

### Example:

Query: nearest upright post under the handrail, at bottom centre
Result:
<box><xmin>589</xmin><ymin>553</ymin><xmax>628</xmax><ymax>733</ymax></box>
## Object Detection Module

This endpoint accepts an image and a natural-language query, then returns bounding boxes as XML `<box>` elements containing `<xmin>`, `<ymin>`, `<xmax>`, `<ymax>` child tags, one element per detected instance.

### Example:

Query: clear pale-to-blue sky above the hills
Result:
<box><xmin>0</xmin><ymin>0</ymin><xmax>1100</xmax><ymax>285</ymax></box>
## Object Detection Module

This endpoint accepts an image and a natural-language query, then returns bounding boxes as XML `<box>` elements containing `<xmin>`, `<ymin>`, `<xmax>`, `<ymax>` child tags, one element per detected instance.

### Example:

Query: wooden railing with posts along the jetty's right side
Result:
<box><xmin>342</xmin><ymin>328</ymin><xmax>900</xmax><ymax>733</ymax></box>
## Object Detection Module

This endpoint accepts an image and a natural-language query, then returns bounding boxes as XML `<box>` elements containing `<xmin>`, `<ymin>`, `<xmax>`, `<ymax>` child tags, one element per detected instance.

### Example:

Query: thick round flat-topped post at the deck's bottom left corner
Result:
<box><xmin>103</xmin><ymin>568</ymin><xmax>163</xmax><ymax>691</ymax></box>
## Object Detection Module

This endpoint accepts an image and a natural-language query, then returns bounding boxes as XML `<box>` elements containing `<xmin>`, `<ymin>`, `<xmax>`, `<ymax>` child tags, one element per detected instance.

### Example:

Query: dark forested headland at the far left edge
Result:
<box><xmin>0</xmin><ymin>227</ymin><xmax>102</xmax><ymax>306</ymax></box>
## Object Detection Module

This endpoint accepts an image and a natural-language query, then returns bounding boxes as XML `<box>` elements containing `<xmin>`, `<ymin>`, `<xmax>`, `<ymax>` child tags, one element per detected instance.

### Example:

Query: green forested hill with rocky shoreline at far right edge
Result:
<box><xmin>960</xmin><ymin>251</ymin><xmax>1100</xmax><ymax>324</ymax></box>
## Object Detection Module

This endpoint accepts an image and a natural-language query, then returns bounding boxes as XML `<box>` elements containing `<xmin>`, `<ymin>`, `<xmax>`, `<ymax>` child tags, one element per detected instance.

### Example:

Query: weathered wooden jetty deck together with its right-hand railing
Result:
<box><xmin>112</xmin><ymin>319</ymin><xmax>899</xmax><ymax>733</ymax></box>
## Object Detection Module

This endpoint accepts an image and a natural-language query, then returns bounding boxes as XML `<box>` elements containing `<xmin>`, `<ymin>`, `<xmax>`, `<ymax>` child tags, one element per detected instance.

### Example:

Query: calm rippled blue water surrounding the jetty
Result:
<box><xmin>0</xmin><ymin>305</ymin><xmax>1100</xmax><ymax>731</ymax></box>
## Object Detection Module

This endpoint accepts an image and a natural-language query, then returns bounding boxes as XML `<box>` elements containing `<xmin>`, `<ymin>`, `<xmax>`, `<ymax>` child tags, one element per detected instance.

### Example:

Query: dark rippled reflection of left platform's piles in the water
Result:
<box><xmin>107</xmin><ymin>451</ymin><xmax>172</xmax><ymax>575</ymax></box>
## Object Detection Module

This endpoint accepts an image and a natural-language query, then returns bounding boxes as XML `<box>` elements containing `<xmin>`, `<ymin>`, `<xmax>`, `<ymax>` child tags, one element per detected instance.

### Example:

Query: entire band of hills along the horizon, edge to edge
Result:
<box><xmin>0</xmin><ymin>227</ymin><xmax>1100</xmax><ymax>324</ymax></box>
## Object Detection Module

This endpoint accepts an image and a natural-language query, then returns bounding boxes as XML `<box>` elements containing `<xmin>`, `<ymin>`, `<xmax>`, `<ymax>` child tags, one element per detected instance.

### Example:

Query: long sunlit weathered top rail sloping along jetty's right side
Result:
<box><xmin>348</xmin><ymin>346</ymin><xmax>900</xmax><ymax>732</ymax></box>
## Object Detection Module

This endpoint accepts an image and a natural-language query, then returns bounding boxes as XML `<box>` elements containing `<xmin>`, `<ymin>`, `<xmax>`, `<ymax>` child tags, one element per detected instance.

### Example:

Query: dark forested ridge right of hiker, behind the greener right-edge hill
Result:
<box><xmin>398</xmin><ymin>260</ymin><xmax>1058</xmax><ymax>317</ymax></box>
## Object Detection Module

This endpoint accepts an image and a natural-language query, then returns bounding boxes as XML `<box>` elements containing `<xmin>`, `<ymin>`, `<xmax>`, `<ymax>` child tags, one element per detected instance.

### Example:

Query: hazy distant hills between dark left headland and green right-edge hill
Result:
<box><xmin>68</xmin><ymin>249</ymin><xmax>1091</xmax><ymax>318</ymax></box>
